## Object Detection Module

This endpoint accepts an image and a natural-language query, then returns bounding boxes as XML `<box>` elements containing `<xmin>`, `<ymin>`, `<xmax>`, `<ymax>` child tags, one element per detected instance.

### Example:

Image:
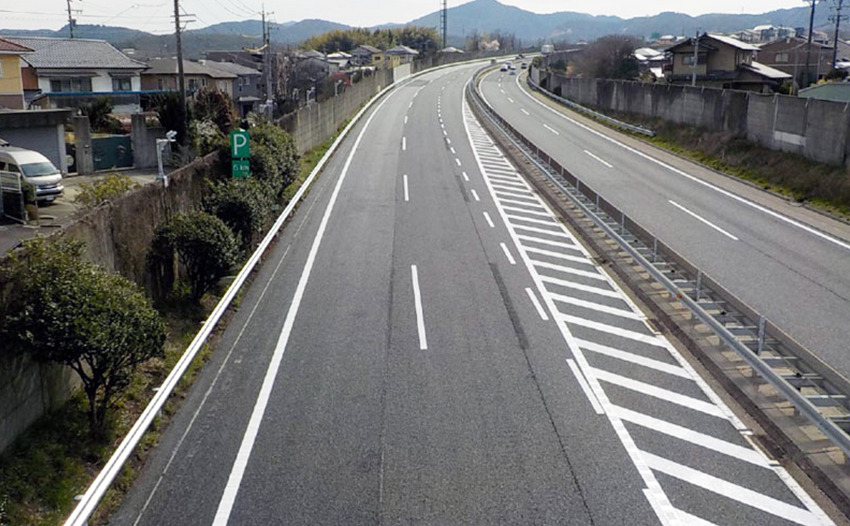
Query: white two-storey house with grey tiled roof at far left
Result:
<box><xmin>4</xmin><ymin>37</ymin><xmax>147</xmax><ymax>113</ymax></box>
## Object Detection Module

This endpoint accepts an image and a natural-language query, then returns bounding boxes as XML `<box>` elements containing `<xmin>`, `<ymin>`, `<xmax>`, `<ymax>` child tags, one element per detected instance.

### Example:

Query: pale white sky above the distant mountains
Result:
<box><xmin>0</xmin><ymin>0</ymin><xmax>805</xmax><ymax>33</ymax></box>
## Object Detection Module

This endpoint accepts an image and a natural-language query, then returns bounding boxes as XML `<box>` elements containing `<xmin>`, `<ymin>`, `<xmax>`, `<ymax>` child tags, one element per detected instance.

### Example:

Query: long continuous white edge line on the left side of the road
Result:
<box><xmin>212</xmin><ymin>82</ymin><xmax>395</xmax><ymax>526</ymax></box>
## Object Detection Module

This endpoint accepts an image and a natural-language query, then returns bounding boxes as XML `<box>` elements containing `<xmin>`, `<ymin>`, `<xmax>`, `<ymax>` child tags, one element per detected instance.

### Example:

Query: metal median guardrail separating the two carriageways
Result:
<box><xmin>467</xmin><ymin>68</ymin><xmax>850</xmax><ymax>462</ymax></box>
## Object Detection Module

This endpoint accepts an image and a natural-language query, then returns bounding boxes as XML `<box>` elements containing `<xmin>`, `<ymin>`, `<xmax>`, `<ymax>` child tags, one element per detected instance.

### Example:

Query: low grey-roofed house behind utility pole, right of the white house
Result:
<box><xmin>142</xmin><ymin>58</ymin><xmax>237</xmax><ymax>98</ymax></box>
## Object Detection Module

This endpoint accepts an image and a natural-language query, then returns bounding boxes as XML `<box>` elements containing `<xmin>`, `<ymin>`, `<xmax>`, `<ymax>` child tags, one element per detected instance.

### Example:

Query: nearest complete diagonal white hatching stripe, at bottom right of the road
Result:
<box><xmin>640</xmin><ymin>451</ymin><xmax>823</xmax><ymax>526</ymax></box>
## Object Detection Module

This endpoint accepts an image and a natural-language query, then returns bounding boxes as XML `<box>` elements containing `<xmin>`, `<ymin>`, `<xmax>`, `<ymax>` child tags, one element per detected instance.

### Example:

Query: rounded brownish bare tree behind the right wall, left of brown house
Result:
<box><xmin>575</xmin><ymin>35</ymin><xmax>640</xmax><ymax>80</ymax></box>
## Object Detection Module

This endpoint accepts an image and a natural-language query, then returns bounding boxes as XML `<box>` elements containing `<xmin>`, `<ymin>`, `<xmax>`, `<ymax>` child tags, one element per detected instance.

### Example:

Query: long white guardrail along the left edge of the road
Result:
<box><xmin>64</xmin><ymin>59</ymin><xmax>510</xmax><ymax>526</ymax></box>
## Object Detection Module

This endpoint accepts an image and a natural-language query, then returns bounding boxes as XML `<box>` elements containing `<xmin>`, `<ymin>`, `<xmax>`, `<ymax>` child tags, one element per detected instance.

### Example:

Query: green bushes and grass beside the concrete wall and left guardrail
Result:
<box><xmin>0</xmin><ymin>83</ymin><xmax>331</xmax><ymax>526</ymax></box>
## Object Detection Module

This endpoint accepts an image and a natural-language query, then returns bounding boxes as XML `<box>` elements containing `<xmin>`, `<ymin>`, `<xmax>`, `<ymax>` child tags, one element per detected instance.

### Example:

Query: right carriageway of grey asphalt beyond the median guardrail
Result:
<box><xmin>482</xmin><ymin>72</ymin><xmax>850</xmax><ymax>382</ymax></box>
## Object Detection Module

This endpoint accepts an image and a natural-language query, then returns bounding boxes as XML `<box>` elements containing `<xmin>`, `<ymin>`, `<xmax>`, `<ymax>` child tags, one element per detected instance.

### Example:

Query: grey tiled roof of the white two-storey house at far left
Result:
<box><xmin>3</xmin><ymin>36</ymin><xmax>145</xmax><ymax>69</ymax></box>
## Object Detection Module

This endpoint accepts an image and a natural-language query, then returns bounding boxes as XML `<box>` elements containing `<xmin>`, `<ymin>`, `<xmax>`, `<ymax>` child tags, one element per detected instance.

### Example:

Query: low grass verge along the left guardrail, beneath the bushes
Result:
<box><xmin>0</xmin><ymin>121</ymin><xmax>348</xmax><ymax>526</ymax></box>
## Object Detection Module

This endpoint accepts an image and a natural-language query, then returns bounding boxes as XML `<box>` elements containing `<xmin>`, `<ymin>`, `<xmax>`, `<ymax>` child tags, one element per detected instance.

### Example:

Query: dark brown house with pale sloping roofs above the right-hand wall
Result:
<box><xmin>666</xmin><ymin>33</ymin><xmax>791</xmax><ymax>93</ymax></box>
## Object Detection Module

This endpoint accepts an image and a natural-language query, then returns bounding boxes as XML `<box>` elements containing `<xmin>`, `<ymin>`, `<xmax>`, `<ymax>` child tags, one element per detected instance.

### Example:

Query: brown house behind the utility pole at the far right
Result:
<box><xmin>758</xmin><ymin>37</ymin><xmax>833</xmax><ymax>85</ymax></box>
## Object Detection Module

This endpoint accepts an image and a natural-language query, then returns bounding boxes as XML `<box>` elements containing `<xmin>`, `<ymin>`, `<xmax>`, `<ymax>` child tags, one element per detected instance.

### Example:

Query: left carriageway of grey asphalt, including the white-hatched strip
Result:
<box><xmin>113</xmin><ymin>66</ymin><xmax>829</xmax><ymax>525</ymax></box>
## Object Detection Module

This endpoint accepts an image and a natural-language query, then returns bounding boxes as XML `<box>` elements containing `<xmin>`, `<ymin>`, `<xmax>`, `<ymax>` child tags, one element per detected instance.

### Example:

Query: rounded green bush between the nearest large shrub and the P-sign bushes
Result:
<box><xmin>148</xmin><ymin>212</ymin><xmax>239</xmax><ymax>302</ymax></box>
